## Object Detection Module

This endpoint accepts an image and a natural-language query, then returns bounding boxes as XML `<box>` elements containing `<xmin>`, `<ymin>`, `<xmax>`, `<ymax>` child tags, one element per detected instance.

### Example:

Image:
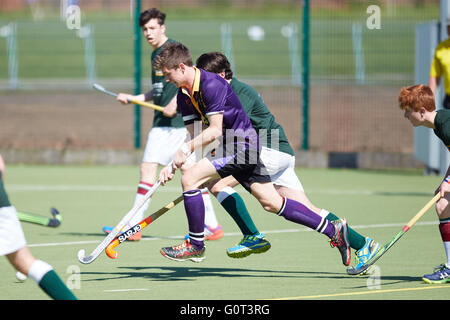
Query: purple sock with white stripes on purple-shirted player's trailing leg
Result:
<box><xmin>278</xmin><ymin>197</ymin><xmax>335</xmax><ymax>239</ymax></box>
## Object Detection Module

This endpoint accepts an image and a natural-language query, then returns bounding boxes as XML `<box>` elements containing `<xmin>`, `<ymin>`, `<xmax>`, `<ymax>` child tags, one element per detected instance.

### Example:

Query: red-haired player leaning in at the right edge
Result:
<box><xmin>398</xmin><ymin>84</ymin><xmax>450</xmax><ymax>283</ymax></box>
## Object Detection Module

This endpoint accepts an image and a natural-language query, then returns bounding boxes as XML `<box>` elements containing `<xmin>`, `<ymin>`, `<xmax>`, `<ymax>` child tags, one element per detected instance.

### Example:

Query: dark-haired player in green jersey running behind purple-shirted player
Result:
<box><xmin>195</xmin><ymin>52</ymin><xmax>380</xmax><ymax>267</ymax></box>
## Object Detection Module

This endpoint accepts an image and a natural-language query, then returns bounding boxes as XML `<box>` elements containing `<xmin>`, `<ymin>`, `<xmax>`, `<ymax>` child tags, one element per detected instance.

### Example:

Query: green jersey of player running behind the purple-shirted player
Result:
<box><xmin>230</xmin><ymin>78</ymin><xmax>294</xmax><ymax>156</ymax></box>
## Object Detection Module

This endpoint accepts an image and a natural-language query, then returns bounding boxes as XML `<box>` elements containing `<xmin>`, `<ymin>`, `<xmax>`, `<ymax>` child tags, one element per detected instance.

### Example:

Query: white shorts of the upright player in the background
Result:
<box><xmin>142</xmin><ymin>127</ymin><xmax>187</xmax><ymax>166</ymax></box>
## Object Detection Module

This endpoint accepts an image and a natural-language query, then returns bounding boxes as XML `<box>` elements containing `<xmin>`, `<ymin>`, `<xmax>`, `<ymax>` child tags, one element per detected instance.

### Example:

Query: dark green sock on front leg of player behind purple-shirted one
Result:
<box><xmin>217</xmin><ymin>188</ymin><xmax>259</xmax><ymax>236</ymax></box>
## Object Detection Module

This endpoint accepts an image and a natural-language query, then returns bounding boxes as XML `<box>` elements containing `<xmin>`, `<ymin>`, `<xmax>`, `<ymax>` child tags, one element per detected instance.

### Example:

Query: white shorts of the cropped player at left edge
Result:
<box><xmin>0</xmin><ymin>206</ymin><xmax>27</xmax><ymax>256</ymax></box>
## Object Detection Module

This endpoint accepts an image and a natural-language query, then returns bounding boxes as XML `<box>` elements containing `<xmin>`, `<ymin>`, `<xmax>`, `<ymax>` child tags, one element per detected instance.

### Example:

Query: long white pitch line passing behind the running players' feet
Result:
<box><xmin>27</xmin><ymin>221</ymin><xmax>438</xmax><ymax>248</ymax></box>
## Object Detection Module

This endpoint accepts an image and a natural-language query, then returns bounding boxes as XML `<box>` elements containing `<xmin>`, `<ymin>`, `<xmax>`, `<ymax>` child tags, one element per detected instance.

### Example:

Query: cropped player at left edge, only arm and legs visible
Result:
<box><xmin>0</xmin><ymin>155</ymin><xmax>76</xmax><ymax>300</ymax></box>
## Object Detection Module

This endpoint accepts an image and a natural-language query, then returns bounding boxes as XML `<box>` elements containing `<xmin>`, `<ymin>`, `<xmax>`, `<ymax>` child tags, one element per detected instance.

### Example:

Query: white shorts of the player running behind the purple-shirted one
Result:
<box><xmin>260</xmin><ymin>147</ymin><xmax>304</xmax><ymax>191</ymax></box>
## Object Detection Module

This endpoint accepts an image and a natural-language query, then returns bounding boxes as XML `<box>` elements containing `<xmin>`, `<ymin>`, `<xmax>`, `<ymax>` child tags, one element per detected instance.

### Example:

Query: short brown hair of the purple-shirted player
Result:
<box><xmin>153</xmin><ymin>42</ymin><xmax>193</xmax><ymax>70</ymax></box>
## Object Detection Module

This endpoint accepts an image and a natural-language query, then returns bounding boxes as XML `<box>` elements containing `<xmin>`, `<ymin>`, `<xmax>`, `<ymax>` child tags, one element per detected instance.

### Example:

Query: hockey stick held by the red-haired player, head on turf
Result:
<box><xmin>347</xmin><ymin>192</ymin><xmax>441</xmax><ymax>276</ymax></box>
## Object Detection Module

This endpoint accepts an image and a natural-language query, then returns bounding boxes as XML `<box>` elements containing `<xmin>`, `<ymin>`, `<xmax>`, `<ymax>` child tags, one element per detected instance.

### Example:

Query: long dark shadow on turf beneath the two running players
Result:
<box><xmin>81</xmin><ymin>266</ymin><xmax>347</xmax><ymax>281</ymax></box>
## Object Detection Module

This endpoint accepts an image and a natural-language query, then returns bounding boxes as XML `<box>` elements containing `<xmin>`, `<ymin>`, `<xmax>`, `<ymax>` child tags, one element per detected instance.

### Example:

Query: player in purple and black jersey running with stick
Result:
<box><xmin>154</xmin><ymin>43</ymin><xmax>350</xmax><ymax>265</ymax></box>
